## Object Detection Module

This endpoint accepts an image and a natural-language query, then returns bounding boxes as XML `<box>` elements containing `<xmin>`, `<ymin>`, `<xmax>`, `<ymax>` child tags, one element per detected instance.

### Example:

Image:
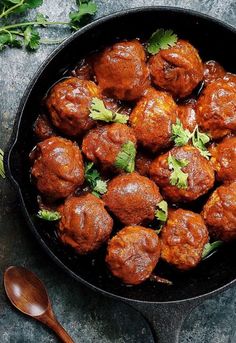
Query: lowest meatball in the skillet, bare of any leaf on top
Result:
<box><xmin>106</xmin><ymin>226</ymin><xmax>160</xmax><ymax>285</ymax></box>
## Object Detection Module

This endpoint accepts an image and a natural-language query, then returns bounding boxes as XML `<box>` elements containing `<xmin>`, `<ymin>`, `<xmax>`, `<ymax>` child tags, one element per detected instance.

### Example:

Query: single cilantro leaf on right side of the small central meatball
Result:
<box><xmin>115</xmin><ymin>141</ymin><xmax>136</xmax><ymax>173</ymax></box>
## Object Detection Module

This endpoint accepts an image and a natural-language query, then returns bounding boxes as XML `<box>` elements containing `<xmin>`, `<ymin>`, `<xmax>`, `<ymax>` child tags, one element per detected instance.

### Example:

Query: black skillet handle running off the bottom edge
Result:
<box><xmin>128</xmin><ymin>299</ymin><xmax>202</xmax><ymax>343</ymax></box>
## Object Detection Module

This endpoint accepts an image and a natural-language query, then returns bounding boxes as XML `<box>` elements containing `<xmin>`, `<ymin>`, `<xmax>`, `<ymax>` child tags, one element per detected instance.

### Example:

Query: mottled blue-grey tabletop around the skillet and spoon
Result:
<box><xmin>0</xmin><ymin>0</ymin><xmax>236</xmax><ymax>343</ymax></box>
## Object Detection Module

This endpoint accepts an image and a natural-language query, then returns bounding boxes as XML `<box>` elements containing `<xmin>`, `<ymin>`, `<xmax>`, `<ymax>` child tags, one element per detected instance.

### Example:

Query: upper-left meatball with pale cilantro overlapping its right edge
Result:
<box><xmin>46</xmin><ymin>77</ymin><xmax>100</xmax><ymax>136</ymax></box>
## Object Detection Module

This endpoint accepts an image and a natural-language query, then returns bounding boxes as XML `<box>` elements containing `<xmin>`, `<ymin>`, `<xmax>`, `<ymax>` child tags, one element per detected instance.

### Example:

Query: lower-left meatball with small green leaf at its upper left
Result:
<box><xmin>59</xmin><ymin>194</ymin><xmax>113</xmax><ymax>254</ymax></box>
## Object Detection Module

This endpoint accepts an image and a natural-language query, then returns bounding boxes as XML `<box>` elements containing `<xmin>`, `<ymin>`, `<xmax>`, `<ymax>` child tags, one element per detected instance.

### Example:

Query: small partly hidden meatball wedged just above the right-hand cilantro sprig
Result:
<box><xmin>178</xmin><ymin>99</ymin><xmax>197</xmax><ymax>131</ymax></box>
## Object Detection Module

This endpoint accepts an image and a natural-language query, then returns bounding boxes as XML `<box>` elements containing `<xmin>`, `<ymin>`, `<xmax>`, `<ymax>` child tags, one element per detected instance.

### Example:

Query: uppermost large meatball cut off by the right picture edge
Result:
<box><xmin>196</xmin><ymin>79</ymin><xmax>236</xmax><ymax>139</ymax></box>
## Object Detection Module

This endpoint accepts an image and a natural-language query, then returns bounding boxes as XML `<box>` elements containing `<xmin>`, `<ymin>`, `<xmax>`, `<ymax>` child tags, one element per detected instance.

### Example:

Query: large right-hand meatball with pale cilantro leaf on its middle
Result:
<box><xmin>150</xmin><ymin>145</ymin><xmax>214</xmax><ymax>202</ymax></box>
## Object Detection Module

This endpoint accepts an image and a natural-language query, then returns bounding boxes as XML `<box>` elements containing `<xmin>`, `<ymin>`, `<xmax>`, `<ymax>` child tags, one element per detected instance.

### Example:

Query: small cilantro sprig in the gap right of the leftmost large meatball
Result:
<box><xmin>85</xmin><ymin>162</ymin><xmax>107</xmax><ymax>197</ymax></box>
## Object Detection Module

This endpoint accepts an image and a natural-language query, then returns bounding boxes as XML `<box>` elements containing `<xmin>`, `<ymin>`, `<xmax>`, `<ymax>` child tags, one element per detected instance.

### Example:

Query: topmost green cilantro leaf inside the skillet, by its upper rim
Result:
<box><xmin>147</xmin><ymin>29</ymin><xmax>178</xmax><ymax>55</ymax></box>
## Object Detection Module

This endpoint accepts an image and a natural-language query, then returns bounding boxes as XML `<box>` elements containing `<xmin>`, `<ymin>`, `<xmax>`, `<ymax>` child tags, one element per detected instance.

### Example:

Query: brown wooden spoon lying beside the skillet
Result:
<box><xmin>4</xmin><ymin>266</ymin><xmax>74</xmax><ymax>343</ymax></box>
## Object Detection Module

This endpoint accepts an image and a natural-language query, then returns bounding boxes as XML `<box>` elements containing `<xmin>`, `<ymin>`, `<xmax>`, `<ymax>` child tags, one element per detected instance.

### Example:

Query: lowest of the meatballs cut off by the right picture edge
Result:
<box><xmin>202</xmin><ymin>182</ymin><xmax>236</xmax><ymax>241</ymax></box>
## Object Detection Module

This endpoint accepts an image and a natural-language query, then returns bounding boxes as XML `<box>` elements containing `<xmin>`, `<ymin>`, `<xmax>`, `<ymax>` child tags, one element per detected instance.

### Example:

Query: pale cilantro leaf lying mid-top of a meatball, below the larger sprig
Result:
<box><xmin>168</xmin><ymin>154</ymin><xmax>189</xmax><ymax>189</ymax></box>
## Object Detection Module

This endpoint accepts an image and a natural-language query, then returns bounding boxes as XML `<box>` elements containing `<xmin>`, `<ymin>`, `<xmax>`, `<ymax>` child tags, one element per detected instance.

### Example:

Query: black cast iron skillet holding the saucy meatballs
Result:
<box><xmin>5</xmin><ymin>7</ymin><xmax>236</xmax><ymax>343</ymax></box>
